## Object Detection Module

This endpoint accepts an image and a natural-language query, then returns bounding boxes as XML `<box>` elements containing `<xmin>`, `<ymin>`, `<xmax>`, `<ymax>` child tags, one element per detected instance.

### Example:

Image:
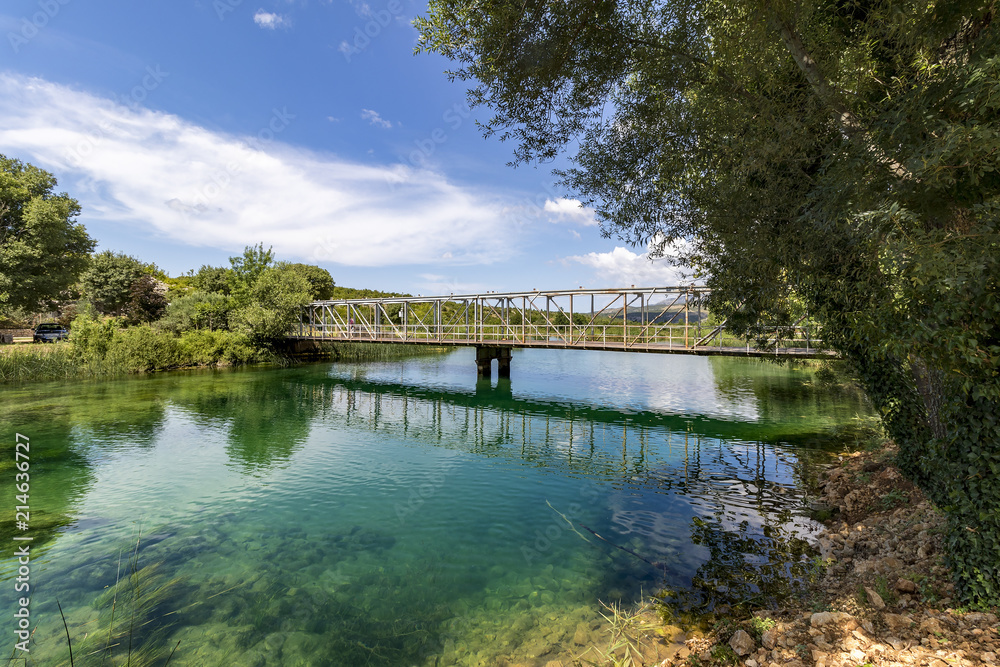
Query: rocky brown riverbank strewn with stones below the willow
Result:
<box><xmin>633</xmin><ymin>448</ymin><xmax>1000</xmax><ymax>667</ymax></box>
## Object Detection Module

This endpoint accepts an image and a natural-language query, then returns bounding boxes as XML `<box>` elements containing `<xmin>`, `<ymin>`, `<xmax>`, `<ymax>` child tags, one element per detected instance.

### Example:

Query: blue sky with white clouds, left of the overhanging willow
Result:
<box><xmin>0</xmin><ymin>0</ymin><xmax>680</xmax><ymax>295</ymax></box>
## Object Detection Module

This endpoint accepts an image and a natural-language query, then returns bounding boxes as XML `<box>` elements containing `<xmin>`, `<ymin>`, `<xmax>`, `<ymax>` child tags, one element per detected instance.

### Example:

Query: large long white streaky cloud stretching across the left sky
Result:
<box><xmin>0</xmin><ymin>73</ymin><xmax>513</xmax><ymax>266</ymax></box>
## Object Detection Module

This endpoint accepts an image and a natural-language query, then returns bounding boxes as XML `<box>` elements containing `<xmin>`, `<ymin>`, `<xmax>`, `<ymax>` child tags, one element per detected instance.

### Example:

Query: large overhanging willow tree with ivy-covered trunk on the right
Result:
<box><xmin>416</xmin><ymin>0</ymin><xmax>1000</xmax><ymax>604</ymax></box>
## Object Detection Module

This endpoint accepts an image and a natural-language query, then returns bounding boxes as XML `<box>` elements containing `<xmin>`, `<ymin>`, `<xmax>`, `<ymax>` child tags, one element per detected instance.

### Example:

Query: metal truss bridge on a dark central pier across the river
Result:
<box><xmin>290</xmin><ymin>285</ymin><xmax>828</xmax><ymax>377</ymax></box>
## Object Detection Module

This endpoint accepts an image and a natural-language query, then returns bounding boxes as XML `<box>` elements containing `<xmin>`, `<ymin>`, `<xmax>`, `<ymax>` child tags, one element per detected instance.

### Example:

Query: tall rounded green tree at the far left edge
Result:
<box><xmin>0</xmin><ymin>155</ymin><xmax>95</xmax><ymax>311</ymax></box>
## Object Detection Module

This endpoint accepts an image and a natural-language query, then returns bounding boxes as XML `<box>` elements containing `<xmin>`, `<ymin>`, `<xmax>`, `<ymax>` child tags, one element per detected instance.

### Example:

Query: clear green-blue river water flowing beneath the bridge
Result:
<box><xmin>0</xmin><ymin>349</ymin><xmax>864</xmax><ymax>665</ymax></box>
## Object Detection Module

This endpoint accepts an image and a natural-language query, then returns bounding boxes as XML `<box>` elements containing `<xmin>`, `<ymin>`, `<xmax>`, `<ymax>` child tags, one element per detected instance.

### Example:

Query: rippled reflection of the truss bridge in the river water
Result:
<box><xmin>311</xmin><ymin>370</ymin><xmax>827</xmax><ymax>518</ymax></box>
